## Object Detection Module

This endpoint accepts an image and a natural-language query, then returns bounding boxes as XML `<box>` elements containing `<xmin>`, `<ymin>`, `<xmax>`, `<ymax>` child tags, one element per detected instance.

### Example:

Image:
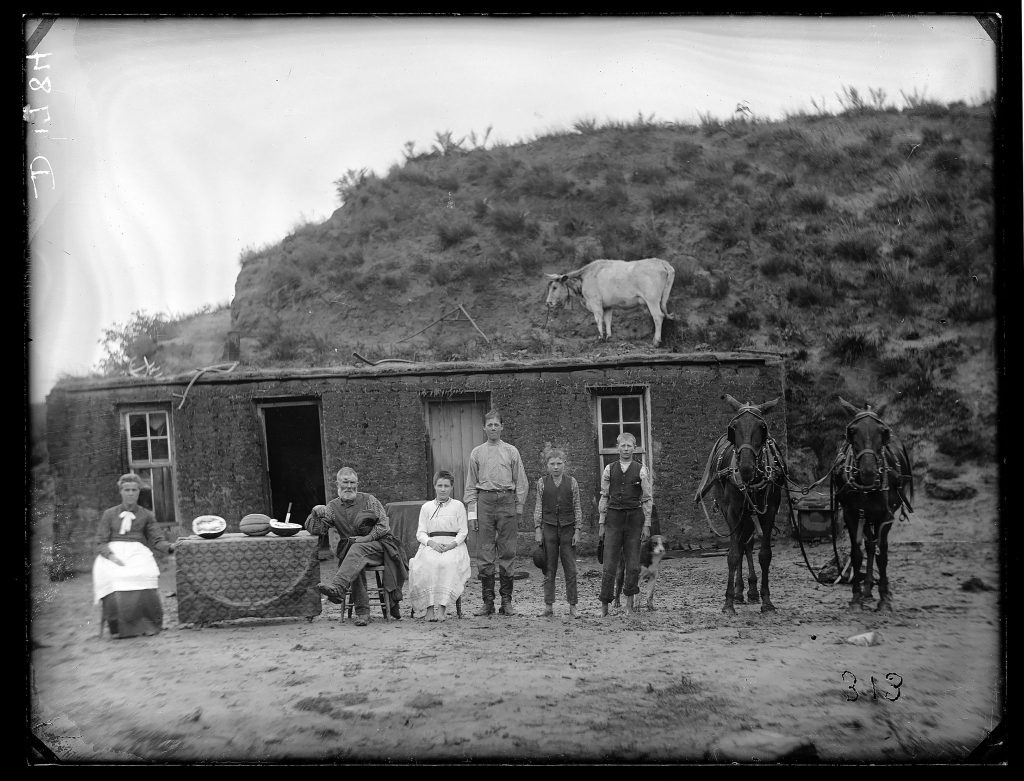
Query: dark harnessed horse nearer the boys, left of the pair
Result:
<box><xmin>696</xmin><ymin>393</ymin><xmax>785</xmax><ymax>613</ymax></box>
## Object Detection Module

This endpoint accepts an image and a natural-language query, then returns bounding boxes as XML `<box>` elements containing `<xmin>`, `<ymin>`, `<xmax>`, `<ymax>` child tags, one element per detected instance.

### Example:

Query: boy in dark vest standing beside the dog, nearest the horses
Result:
<box><xmin>597</xmin><ymin>432</ymin><xmax>654</xmax><ymax>615</ymax></box>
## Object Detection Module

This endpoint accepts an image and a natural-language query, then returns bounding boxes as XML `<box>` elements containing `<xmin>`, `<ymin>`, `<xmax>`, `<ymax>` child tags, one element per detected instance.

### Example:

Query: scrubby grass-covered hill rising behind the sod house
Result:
<box><xmin>119</xmin><ymin>93</ymin><xmax>996</xmax><ymax>476</ymax></box>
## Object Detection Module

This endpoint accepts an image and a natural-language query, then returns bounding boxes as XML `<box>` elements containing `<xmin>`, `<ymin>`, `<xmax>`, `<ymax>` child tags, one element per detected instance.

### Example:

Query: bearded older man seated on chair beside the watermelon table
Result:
<box><xmin>305</xmin><ymin>467</ymin><xmax>409</xmax><ymax>626</ymax></box>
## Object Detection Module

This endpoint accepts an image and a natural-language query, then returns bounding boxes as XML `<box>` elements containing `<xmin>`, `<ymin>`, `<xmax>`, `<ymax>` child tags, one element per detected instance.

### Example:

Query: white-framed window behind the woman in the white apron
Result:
<box><xmin>123</xmin><ymin>408</ymin><xmax>176</xmax><ymax>523</ymax></box>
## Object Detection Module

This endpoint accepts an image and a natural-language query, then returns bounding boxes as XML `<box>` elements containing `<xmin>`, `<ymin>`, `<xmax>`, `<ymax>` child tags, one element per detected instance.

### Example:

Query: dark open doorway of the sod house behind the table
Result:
<box><xmin>259</xmin><ymin>401</ymin><xmax>325</xmax><ymax>523</ymax></box>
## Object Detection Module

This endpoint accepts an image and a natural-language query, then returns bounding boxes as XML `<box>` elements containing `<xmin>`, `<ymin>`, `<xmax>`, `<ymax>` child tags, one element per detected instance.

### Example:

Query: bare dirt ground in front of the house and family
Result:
<box><xmin>27</xmin><ymin>464</ymin><xmax>1007</xmax><ymax>765</ymax></box>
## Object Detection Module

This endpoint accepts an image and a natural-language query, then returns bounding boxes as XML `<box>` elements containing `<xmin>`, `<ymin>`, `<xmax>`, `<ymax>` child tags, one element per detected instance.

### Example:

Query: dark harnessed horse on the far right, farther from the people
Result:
<box><xmin>831</xmin><ymin>396</ymin><xmax>913</xmax><ymax>612</ymax></box>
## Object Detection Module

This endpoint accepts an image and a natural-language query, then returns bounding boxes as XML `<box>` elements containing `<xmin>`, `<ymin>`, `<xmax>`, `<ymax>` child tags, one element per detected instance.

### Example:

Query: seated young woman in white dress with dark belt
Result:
<box><xmin>409</xmin><ymin>470</ymin><xmax>471</xmax><ymax>621</ymax></box>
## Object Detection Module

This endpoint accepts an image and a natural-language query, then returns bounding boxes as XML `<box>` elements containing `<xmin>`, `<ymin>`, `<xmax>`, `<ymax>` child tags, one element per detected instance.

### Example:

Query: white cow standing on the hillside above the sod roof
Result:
<box><xmin>545</xmin><ymin>258</ymin><xmax>676</xmax><ymax>347</ymax></box>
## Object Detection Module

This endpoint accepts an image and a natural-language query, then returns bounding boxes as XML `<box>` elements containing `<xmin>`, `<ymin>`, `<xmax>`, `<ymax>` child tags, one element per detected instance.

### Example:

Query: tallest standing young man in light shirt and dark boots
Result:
<box><xmin>463</xmin><ymin>409</ymin><xmax>527</xmax><ymax>615</ymax></box>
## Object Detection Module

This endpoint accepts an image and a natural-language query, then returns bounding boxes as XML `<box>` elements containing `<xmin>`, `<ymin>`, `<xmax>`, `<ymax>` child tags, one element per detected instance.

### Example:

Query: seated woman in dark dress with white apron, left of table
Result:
<box><xmin>92</xmin><ymin>473</ymin><xmax>174</xmax><ymax>638</ymax></box>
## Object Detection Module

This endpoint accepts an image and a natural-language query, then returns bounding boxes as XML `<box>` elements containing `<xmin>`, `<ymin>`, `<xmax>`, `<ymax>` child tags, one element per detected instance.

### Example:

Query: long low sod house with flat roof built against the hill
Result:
<box><xmin>46</xmin><ymin>352</ymin><xmax>786</xmax><ymax>572</ymax></box>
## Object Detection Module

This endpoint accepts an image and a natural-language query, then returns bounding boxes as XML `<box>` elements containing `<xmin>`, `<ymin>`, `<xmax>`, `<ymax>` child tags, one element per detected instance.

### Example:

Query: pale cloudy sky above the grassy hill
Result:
<box><xmin>24</xmin><ymin>14</ymin><xmax>998</xmax><ymax>402</ymax></box>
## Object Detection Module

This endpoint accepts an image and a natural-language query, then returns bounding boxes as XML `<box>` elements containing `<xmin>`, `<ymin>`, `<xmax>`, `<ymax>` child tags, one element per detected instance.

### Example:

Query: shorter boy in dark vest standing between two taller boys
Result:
<box><xmin>534</xmin><ymin>449</ymin><xmax>583</xmax><ymax>618</ymax></box>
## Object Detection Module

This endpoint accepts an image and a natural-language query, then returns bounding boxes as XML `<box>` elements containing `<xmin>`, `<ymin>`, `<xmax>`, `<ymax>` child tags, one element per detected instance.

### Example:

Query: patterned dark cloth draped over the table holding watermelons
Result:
<box><xmin>174</xmin><ymin>527</ymin><xmax>321</xmax><ymax>623</ymax></box>
